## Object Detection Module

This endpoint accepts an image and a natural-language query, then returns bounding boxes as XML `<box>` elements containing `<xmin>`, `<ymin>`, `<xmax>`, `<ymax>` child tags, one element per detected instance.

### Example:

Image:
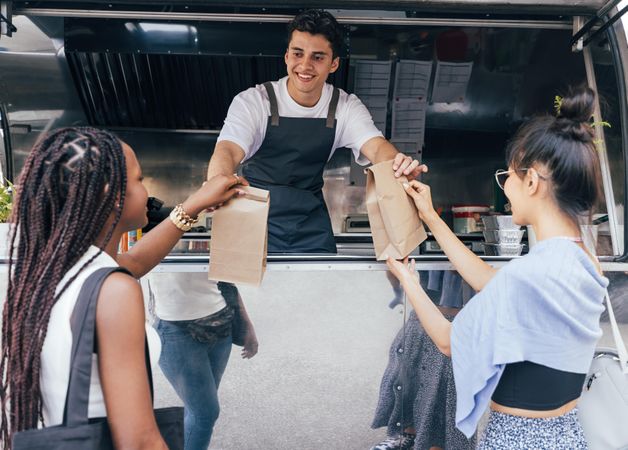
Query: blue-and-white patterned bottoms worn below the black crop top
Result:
<box><xmin>478</xmin><ymin>409</ymin><xmax>588</xmax><ymax>450</ymax></box>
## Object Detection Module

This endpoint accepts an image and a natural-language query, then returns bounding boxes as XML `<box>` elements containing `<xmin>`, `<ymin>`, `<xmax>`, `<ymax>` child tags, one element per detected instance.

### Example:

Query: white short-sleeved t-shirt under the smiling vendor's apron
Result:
<box><xmin>218</xmin><ymin>77</ymin><xmax>383</xmax><ymax>165</ymax></box>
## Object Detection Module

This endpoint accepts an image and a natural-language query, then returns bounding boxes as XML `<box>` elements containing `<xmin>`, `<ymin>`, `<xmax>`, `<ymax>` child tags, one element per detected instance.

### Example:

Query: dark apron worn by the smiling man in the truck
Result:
<box><xmin>242</xmin><ymin>83</ymin><xmax>340</xmax><ymax>253</ymax></box>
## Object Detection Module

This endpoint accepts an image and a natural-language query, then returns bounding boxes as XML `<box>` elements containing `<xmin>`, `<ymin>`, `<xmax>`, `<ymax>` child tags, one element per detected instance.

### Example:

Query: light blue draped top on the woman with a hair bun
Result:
<box><xmin>451</xmin><ymin>238</ymin><xmax>608</xmax><ymax>437</ymax></box>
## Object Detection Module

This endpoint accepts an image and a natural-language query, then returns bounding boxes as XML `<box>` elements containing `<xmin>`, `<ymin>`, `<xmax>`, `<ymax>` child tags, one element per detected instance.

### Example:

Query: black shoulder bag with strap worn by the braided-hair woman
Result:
<box><xmin>13</xmin><ymin>267</ymin><xmax>183</xmax><ymax>450</ymax></box>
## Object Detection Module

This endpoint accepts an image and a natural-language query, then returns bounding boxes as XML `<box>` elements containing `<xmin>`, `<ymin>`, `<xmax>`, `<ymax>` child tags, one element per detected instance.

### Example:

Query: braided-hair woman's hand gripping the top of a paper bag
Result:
<box><xmin>183</xmin><ymin>175</ymin><xmax>249</xmax><ymax>217</ymax></box>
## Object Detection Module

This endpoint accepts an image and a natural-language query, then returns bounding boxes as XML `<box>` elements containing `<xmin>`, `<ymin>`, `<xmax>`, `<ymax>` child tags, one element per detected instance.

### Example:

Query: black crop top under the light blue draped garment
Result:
<box><xmin>492</xmin><ymin>361</ymin><xmax>586</xmax><ymax>411</ymax></box>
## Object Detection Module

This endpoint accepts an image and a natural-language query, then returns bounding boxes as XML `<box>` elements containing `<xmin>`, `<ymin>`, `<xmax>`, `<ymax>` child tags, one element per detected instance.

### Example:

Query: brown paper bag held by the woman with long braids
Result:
<box><xmin>209</xmin><ymin>186</ymin><xmax>270</xmax><ymax>286</ymax></box>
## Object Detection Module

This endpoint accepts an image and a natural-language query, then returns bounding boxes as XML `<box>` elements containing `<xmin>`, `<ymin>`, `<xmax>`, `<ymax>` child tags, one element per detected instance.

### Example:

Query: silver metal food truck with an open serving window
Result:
<box><xmin>0</xmin><ymin>0</ymin><xmax>628</xmax><ymax>449</ymax></box>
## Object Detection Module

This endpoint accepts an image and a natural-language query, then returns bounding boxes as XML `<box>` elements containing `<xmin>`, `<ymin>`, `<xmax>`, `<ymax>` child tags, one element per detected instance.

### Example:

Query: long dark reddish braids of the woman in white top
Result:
<box><xmin>0</xmin><ymin>127</ymin><xmax>127</xmax><ymax>449</ymax></box>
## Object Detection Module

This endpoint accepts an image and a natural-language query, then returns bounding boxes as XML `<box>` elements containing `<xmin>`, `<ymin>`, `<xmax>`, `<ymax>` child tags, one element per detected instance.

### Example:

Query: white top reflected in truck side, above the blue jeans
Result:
<box><xmin>148</xmin><ymin>272</ymin><xmax>227</xmax><ymax>320</ymax></box>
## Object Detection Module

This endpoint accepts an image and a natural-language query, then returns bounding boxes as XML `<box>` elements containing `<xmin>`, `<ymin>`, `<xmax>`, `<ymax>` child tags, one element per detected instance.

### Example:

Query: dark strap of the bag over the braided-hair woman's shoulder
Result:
<box><xmin>63</xmin><ymin>267</ymin><xmax>153</xmax><ymax>426</ymax></box>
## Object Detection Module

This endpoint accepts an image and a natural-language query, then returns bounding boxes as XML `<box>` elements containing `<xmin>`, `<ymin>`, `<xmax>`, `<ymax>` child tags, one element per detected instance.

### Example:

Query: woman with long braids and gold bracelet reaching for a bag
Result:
<box><xmin>0</xmin><ymin>128</ymin><xmax>247</xmax><ymax>449</ymax></box>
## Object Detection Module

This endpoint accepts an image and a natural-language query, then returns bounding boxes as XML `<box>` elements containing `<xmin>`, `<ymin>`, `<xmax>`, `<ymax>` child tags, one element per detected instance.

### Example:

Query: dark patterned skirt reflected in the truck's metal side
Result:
<box><xmin>371</xmin><ymin>271</ymin><xmax>475</xmax><ymax>450</ymax></box>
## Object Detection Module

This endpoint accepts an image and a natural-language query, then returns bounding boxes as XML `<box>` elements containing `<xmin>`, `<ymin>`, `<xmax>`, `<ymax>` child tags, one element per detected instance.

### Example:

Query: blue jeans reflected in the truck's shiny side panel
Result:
<box><xmin>155</xmin><ymin>320</ymin><xmax>231</xmax><ymax>450</ymax></box>
